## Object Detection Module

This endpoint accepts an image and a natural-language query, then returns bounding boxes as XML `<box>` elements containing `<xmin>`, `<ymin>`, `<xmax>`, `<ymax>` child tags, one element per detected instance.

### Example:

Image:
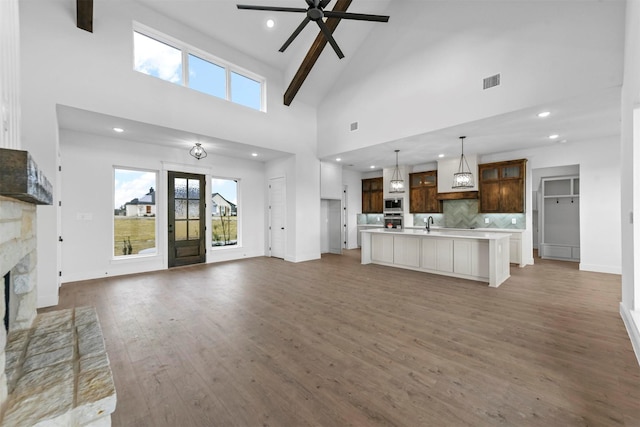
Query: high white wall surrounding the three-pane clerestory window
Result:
<box><xmin>20</xmin><ymin>0</ymin><xmax>320</xmax><ymax>306</ymax></box>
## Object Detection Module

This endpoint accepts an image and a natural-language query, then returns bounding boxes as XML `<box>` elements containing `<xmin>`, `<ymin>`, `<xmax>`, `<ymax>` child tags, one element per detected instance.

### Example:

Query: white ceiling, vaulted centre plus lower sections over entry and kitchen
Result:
<box><xmin>59</xmin><ymin>0</ymin><xmax>620</xmax><ymax>171</ymax></box>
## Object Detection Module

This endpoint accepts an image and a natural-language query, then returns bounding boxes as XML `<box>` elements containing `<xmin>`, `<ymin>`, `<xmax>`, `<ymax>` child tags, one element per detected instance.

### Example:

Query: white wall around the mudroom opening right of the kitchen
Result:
<box><xmin>479</xmin><ymin>137</ymin><xmax>622</xmax><ymax>274</ymax></box>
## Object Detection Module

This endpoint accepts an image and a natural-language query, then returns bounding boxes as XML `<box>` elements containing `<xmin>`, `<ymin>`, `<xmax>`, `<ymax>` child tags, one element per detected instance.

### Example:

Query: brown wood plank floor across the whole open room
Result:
<box><xmin>45</xmin><ymin>250</ymin><xmax>640</xmax><ymax>427</ymax></box>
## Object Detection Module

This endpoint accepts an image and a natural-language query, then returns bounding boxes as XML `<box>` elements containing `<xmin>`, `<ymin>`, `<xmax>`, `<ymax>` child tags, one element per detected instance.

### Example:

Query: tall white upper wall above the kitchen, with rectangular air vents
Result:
<box><xmin>318</xmin><ymin>1</ymin><xmax>624</xmax><ymax>157</ymax></box>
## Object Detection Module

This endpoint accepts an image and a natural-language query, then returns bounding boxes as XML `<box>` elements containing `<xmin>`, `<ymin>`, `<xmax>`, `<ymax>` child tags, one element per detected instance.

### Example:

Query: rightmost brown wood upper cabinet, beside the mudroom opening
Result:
<box><xmin>478</xmin><ymin>159</ymin><xmax>527</xmax><ymax>213</ymax></box>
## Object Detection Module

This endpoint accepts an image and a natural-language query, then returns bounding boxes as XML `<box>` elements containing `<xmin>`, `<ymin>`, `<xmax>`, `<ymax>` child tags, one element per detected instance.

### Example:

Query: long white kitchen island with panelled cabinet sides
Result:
<box><xmin>361</xmin><ymin>228</ymin><xmax>510</xmax><ymax>288</ymax></box>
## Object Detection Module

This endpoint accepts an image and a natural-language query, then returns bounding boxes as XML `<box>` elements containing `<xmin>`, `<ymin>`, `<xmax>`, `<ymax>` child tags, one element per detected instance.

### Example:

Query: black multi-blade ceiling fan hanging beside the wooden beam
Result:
<box><xmin>237</xmin><ymin>0</ymin><xmax>389</xmax><ymax>59</ymax></box>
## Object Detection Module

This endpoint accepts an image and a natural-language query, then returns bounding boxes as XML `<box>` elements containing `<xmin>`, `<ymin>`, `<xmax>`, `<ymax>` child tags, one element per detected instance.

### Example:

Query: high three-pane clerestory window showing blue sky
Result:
<box><xmin>133</xmin><ymin>24</ymin><xmax>266</xmax><ymax>111</ymax></box>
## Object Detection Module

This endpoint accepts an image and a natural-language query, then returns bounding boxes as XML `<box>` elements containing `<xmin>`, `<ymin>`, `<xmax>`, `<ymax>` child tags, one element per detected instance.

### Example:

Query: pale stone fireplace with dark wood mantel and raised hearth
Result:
<box><xmin>0</xmin><ymin>149</ymin><xmax>116</xmax><ymax>427</ymax></box>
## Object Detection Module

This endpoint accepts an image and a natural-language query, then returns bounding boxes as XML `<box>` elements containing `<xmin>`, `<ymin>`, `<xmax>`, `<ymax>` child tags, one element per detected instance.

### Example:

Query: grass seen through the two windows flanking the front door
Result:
<box><xmin>113</xmin><ymin>216</ymin><xmax>238</xmax><ymax>256</ymax></box>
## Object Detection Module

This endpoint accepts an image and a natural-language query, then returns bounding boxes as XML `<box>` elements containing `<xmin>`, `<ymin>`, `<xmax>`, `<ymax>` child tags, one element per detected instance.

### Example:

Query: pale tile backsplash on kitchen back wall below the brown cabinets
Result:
<box><xmin>413</xmin><ymin>199</ymin><xmax>525</xmax><ymax>230</ymax></box>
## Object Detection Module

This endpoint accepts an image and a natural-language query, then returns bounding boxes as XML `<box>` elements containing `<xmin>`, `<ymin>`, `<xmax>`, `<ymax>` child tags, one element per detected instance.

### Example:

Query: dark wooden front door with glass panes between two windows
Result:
<box><xmin>168</xmin><ymin>171</ymin><xmax>206</xmax><ymax>267</ymax></box>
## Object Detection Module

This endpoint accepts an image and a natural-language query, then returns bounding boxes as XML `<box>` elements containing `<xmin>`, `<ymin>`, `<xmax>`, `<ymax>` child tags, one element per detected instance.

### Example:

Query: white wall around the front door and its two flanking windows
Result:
<box><xmin>60</xmin><ymin>130</ymin><xmax>265</xmax><ymax>282</ymax></box>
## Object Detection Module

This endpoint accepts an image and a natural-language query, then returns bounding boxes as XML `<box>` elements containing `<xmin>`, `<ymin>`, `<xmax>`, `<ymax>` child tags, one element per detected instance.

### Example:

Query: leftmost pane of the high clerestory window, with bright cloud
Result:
<box><xmin>133</xmin><ymin>31</ymin><xmax>182</xmax><ymax>84</ymax></box>
